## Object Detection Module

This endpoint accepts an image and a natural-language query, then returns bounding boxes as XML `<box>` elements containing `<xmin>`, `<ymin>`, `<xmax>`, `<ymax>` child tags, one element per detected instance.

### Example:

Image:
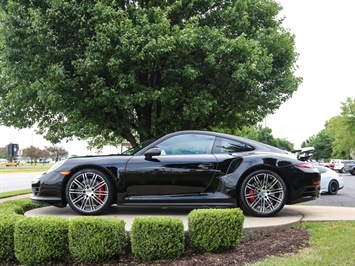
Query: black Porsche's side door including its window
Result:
<box><xmin>122</xmin><ymin>134</ymin><xmax>217</xmax><ymax>196</ymax></box>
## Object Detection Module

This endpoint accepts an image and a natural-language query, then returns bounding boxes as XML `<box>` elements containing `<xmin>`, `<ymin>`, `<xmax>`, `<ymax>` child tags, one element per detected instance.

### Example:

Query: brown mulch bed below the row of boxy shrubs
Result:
<box><xmin>39</xmin><ymin>228</ymin><xmax>310</xmax><ymax>266</ymax></box>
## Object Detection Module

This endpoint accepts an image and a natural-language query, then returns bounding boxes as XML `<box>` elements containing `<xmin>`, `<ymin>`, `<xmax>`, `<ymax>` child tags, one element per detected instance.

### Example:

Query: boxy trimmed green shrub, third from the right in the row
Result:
<box><xmin>69</xmin><ymin>217</ymin><xmax>127</xmax><ymax>262</ymax></box>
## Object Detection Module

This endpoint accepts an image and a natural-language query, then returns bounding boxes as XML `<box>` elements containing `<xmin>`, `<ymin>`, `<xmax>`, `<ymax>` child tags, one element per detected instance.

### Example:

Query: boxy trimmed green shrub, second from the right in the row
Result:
<box><xmin>130</xmin><ymin>217</ymin><xmax>185</xmax><ymax>261</ymax></box>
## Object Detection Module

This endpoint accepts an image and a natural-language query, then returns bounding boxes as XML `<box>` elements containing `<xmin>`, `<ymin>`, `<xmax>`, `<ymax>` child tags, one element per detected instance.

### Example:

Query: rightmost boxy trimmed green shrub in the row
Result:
<box><xmin>188</xmin><ymin>209</ymin><xmax>244</xmax><ymax>252</ymax></box>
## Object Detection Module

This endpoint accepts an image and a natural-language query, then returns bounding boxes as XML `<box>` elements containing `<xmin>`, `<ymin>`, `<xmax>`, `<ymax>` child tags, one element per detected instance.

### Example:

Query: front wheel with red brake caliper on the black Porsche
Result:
<box><xmin>65</xmin><ymin>169</ymin><xmax>114</xmax><ymax>215</ymax></box>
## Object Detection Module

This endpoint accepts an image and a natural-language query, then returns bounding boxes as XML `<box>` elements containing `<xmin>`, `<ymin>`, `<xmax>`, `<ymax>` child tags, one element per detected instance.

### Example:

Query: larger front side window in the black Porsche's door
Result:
<box><xmin>157</xmin><ymin>134</ymin><xmax>215</xmax><ymax>155</ymax></box>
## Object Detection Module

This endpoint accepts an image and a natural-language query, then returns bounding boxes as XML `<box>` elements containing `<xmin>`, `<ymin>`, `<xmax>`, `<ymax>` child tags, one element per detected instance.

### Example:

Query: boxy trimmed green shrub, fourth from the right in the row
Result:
<box><xmin>14</xmin><ymin>217</ymin><xmax>69</xmax><ymax>265</ymax></box>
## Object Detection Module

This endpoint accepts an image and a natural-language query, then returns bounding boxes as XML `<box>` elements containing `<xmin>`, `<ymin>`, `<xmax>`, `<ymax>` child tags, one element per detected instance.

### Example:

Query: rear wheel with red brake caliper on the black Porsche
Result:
<box><xmin>238</xmin><ymin>170</ymin><xmax>287</xmax><ymax>217</ymax></box>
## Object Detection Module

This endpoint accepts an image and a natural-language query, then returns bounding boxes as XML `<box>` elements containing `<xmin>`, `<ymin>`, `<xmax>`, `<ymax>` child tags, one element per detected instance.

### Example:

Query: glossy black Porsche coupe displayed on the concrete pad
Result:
<box><xmin>31</xmin><ymin>130</ymin><xmax>320</xmax><ymax>217</ymax></box>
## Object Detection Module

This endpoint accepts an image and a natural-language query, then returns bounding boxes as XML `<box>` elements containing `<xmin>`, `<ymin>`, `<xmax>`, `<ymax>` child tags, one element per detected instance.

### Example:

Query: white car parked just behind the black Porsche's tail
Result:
<box><xmin>316</xmin><ymin>166</ymin><xmax>344</xmax><ymax>195</ymax></box>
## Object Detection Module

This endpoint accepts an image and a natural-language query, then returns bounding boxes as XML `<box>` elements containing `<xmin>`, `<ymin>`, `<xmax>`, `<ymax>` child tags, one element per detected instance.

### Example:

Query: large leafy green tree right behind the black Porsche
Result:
<box><xmin>0</xmin><ymin>0</ymin><xmax>301</xmax><ymax>146</ymax></box>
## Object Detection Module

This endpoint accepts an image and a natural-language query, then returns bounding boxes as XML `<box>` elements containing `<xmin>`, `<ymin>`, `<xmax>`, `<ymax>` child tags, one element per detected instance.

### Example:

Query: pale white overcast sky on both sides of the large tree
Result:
<box><xmin>0</xmin><ymin>0</ymin><xmax>355</xmax><ymax>155</ymax></box>
